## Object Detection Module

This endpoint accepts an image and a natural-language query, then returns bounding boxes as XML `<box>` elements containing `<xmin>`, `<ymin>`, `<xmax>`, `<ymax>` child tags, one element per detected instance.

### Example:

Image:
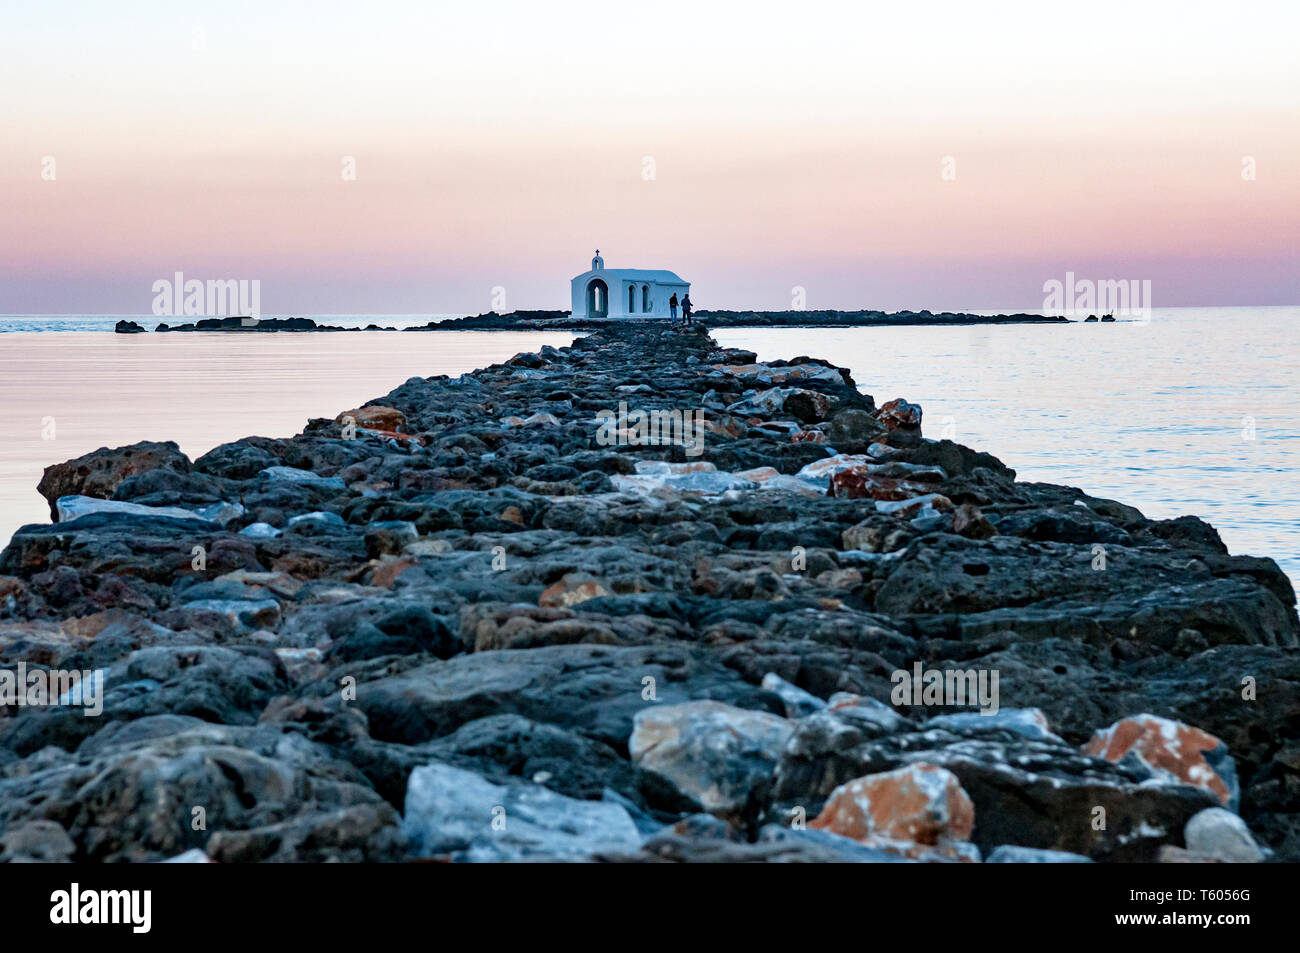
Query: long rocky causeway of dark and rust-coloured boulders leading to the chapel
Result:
<box><xmin>0</xmin><ymin>322</ymin><xmax>1300</xmax><ymax>862</ymax></box>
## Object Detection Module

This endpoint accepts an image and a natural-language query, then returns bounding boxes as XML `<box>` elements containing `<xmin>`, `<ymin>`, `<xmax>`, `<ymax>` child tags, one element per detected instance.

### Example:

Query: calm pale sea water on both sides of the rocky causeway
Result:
<box><xmin>0</xmin><ymin>307</ymin><xmax>1300</xmax><ymax>585</ymax></box>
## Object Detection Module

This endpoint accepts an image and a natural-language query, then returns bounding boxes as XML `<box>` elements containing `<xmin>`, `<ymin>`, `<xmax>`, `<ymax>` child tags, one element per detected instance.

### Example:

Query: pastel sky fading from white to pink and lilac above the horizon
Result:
<box><xmin>0</xmin><ymin>0</ymin><xmax>1300</xmax><ymax>313</ymax></box>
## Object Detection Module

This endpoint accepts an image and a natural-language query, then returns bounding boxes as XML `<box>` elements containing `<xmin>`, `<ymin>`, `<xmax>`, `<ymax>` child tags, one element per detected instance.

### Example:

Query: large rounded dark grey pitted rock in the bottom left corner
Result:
<box><xmin>0</xmin><ymin>716</ymin><xmax>400</xmax><ymax>862</ymax></box>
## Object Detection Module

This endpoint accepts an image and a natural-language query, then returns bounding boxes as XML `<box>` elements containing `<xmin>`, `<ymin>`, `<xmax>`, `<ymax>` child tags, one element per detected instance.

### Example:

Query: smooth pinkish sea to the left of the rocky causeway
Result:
<box><xmin>0</xmin><ymin>327</ymin><xmax>572</xmax><ymax>547</ymax></box>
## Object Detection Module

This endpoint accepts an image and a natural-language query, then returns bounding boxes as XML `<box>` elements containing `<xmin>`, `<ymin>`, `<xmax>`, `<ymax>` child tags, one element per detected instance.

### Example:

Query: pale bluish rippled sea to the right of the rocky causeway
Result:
<box><xmin>714</xmin><ymin>307</ymin><xmax>1300</xmax><ymax>586</ymax></box>
